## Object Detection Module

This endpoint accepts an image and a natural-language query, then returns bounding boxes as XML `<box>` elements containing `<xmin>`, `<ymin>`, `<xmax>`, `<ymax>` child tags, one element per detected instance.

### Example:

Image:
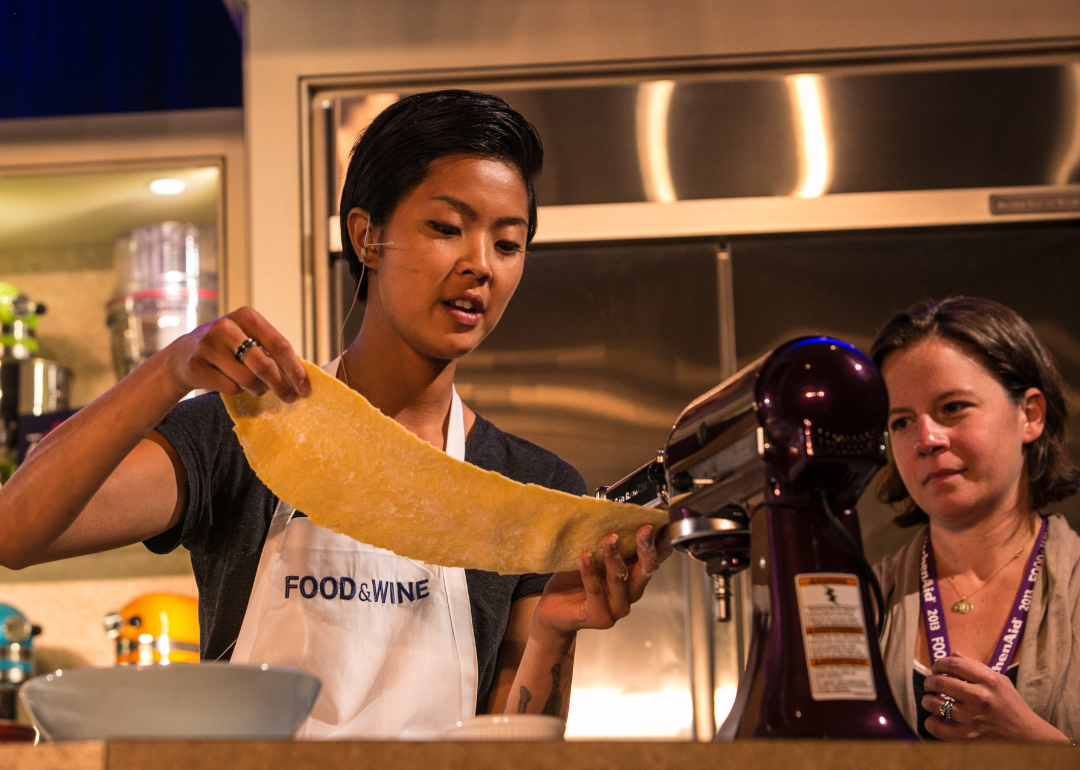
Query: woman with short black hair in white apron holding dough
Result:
<box><xmin>0</xmin><ymin>91</ymin><xmax>670</xmax><ymax>738</ymax></box>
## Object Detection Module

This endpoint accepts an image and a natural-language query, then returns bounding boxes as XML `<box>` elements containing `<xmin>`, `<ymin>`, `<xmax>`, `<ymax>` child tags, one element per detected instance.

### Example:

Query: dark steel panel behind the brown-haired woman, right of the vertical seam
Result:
<box><xmin>730</xmin><ymin>221</ymin><xmax>1080</xmax><ymax>563</ymax></box>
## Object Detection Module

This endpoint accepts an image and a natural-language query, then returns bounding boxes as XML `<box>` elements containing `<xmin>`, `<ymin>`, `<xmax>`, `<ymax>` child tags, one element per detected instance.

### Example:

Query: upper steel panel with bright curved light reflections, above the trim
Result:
<box><xmin>328</xmin><ymin>57</ymin><xmax>1080</xmax><ymax>206</ymax></box>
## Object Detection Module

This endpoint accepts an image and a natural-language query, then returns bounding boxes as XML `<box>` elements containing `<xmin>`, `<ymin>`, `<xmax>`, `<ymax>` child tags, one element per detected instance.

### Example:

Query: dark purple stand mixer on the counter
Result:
<box><xmin>597</xmin><ymin>337</ymin><xmax>916</xmax><ymax>740</ymax></box>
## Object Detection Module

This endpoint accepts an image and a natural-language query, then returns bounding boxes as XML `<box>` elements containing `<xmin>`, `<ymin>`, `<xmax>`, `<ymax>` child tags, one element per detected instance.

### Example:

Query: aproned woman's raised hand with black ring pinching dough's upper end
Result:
<box><xmin>162</xmin><ymin>307</ymin><xmax>311</xmax><ymax>404</ymax></box>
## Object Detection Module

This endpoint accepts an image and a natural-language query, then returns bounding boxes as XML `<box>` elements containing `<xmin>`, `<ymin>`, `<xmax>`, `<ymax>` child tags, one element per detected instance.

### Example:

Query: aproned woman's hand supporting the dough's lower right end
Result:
<box><xmin>532</xmin><ymin>525</ymin><xmax>672</xmax><ymax>637</ymax></box>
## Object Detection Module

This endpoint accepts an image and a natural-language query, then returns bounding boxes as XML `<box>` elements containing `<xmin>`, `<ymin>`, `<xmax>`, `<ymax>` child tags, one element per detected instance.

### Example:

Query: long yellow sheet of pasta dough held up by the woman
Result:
<box><xmin>222</xmin><ymin>362</ymin><xmax>667</xmax><ymax>575</ymax></box>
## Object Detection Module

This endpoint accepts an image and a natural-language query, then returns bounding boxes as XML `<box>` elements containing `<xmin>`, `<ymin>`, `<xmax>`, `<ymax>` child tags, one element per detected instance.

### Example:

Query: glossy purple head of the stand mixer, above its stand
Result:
<box><xmin>662</xmin><ymin>337</ymin><xmax>888</xmax><ymax>620</ymax></box>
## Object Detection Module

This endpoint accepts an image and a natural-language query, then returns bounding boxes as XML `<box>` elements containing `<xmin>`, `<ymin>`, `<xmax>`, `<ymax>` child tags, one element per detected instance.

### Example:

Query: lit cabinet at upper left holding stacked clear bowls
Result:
<box><xmin>0</xmin><ymin>110</ymin><xmax>247</xmax><ymax>584</ymax></box>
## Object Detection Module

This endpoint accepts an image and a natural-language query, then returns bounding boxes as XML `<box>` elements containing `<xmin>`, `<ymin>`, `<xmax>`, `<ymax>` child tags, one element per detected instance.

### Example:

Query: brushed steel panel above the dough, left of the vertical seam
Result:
<box><xmin>457</xmin><ymin>241</ymin><xmax>721</xmax><ymax>489</ymax></box>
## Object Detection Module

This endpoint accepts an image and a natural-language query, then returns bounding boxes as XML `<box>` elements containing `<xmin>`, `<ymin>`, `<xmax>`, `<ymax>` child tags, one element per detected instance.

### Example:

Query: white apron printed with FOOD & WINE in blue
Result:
<box><xmin>232</xmin><ymin>361</ymin><xmax>477</xmax><ymax>739</ymax></box>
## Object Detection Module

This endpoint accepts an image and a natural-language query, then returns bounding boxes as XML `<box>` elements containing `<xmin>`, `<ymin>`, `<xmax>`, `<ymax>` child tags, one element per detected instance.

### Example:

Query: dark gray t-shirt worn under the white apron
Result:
<box><xmin>146</xmin><ymin>393</ymin><xmax>585</xmax><ymax>712</ymax></box>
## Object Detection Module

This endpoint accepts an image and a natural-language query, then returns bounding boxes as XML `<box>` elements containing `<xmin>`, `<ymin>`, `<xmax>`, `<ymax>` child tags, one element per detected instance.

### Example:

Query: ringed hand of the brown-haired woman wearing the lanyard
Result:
<box><xmin>922</xmin><ymin>652</ymin><xmax>1069</xmax><ymax>743</ymax></box>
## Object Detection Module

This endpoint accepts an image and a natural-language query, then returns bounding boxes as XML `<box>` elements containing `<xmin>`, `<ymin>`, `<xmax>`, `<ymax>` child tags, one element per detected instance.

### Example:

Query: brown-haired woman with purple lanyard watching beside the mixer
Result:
<box><xmin>870</xmin><ymin>297</ymin><xmax>1080</xmax><ymax>743</ymax></box>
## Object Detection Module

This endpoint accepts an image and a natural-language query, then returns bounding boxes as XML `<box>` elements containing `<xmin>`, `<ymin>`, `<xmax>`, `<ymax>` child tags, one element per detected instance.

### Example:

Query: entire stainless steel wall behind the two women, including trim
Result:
<box><xmin>319</xmin><ymin>52</ymin><xmax>1080</xmax><ymax>738</ymax></box>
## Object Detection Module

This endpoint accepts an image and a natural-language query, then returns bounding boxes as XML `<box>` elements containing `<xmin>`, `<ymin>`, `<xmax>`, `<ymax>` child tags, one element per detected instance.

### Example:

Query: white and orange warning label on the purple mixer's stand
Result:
<box><xmin>795</xmin><ymin>572</ymin><xmax>877</xmax><ymax>701</ymax></box>
